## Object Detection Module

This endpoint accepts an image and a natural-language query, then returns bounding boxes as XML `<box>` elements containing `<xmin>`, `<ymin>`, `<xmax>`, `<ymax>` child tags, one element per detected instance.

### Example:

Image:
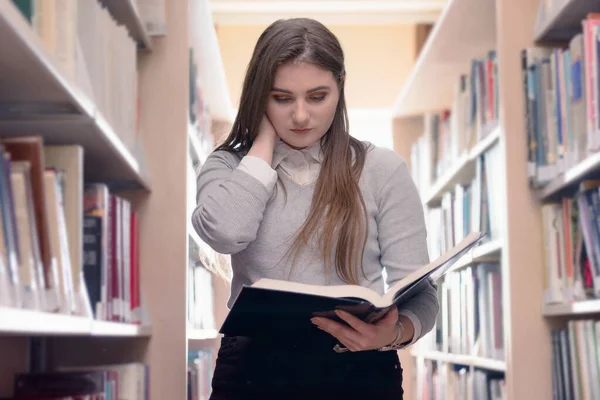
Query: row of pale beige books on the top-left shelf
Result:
<box><xmin>8</xmin><ymin>0</ymin><xmax>139</xmax><ymax>152</ymax></box>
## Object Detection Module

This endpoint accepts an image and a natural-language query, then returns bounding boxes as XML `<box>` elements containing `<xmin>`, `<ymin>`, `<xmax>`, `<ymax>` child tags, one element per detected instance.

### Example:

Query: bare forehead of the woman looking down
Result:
<box><xmin>273</xmin><ymin>62</ymin><xmax>335</xmax><ymax>92</ymax></box>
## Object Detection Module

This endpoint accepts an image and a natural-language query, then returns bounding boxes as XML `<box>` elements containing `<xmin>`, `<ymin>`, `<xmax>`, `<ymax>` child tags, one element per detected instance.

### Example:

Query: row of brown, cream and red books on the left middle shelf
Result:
<box><xmin>0</xmin><ymin>136</ymin><xmax>141</xmax><ymax>323</ymax></box>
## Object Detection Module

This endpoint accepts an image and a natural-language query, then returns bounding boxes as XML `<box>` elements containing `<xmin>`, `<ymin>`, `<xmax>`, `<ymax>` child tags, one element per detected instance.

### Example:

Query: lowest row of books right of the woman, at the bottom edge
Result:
<box><xmin>416</xmin><ymin>360</ymin><xmax>506</xmax><ymax>400</ymax></box>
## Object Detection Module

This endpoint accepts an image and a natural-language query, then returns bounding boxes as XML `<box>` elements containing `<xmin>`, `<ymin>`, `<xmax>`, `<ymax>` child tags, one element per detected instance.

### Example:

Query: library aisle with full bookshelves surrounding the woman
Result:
<box><xmin>0</xmin><ymin>0</ymin><xmax>600</xmax><ymax>400</ymax></box>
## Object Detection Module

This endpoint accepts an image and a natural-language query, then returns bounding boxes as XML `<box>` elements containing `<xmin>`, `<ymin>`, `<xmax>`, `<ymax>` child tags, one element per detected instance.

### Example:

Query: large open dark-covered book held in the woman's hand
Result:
<box><xmin>219</xmin><ymin>232</ymin><xmax>484</xmax><ymax>337</ymax></box>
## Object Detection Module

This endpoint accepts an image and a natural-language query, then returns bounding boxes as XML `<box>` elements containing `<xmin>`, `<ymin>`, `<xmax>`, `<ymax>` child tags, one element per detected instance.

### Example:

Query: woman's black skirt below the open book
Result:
<box><xmin>210</xmin><ymin>336</ymin><xmax>404</xmax><ymax>400</ymax></box>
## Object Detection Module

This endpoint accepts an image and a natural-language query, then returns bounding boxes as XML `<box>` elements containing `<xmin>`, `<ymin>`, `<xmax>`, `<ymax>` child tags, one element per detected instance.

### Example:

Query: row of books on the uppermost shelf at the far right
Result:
<box><xmin>521</xmin><ymin>14</ymin><xmax>600</xmax><ymax>188</ymax></box>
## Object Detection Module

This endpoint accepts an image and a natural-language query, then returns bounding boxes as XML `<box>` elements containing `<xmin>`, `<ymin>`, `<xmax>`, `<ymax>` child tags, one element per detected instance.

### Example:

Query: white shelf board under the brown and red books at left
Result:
<box><xmin>0</xmin><ymin>307</ymin><xmax>152</xmax><ymax>337</ymax></box>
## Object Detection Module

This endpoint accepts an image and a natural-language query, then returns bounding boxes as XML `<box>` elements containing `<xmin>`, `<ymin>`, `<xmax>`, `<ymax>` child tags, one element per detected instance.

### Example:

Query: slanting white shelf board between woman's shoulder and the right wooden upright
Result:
<box><xmin>423</xmin><ymin>127</ymin><xmax>502</xmax><ymax>206</ymax></box>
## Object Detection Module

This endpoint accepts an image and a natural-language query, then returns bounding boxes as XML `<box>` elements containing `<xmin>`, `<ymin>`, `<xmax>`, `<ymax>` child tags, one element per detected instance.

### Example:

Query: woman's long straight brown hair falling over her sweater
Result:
<box><xmin>217</xmin><ymin>18</ymin><xmax>367</xmax><ymax>284</ymax></box>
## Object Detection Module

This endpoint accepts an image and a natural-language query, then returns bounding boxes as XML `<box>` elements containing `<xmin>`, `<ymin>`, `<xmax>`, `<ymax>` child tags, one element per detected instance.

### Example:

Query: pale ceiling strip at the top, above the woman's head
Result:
<box><xmin>210</xmin><ymin>0</ymin><xmax>447</xmax><ymax>25</ymax></box>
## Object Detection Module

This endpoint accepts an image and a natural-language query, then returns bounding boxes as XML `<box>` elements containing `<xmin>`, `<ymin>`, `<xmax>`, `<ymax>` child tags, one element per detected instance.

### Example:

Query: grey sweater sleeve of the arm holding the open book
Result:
<box><xmin>377</xmin><ymin>160</ymin><xmax>439</xmax><ymax>345</ymax></box>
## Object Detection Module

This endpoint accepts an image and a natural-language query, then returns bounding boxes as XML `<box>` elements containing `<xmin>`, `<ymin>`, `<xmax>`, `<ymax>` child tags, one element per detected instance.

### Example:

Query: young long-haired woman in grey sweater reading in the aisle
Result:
<box><xmin>192</xmin><ymin>19</ymin><xmax>438</xmax><ymax>400</ymax></box>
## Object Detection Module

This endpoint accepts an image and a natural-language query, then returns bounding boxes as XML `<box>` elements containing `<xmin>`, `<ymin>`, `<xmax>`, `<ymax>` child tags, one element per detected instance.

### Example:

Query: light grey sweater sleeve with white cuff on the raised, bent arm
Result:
<box><xmin>192</xmin><ymin>151</ymin><xmax>277</xmax><ymax>254</ymax></box>
